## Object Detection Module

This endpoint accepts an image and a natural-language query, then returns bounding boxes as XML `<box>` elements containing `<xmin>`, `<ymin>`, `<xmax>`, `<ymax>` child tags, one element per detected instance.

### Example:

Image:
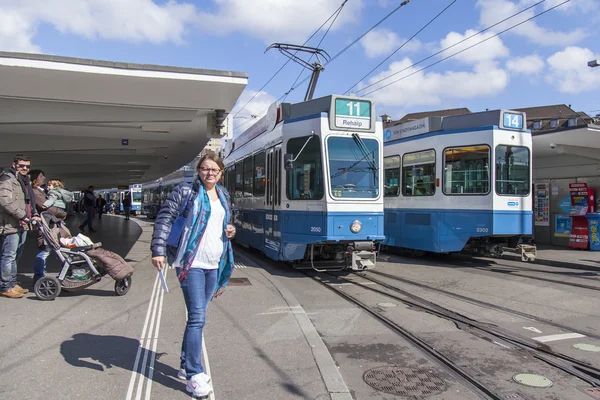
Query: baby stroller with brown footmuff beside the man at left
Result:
<box><xmin>33</xmin><ymin>212</ymin><xmax>133</xmax><ymax>300</ymax></box>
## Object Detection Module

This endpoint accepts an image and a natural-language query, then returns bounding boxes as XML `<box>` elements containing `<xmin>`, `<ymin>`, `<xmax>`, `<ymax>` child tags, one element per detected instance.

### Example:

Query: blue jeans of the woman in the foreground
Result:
<box><xmin>176</xmin><ymin>268</ymin><xmax>218</xmax><ymax>379</ymax></box>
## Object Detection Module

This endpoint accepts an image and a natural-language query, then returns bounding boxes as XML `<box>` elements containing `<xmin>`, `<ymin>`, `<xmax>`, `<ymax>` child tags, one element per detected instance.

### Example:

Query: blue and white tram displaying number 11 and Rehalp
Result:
<box><xmin>224</xmin><ymin>95</ymin><xmax>384</xmax><ymax>270</ymax></box>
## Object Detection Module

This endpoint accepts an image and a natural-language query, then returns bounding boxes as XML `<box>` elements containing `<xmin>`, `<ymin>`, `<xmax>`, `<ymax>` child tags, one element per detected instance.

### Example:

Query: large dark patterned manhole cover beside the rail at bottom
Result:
<box><xmin>363</xmin><ymin>366</ymin><xmax>446</xmax><ymax>397</ymax></box>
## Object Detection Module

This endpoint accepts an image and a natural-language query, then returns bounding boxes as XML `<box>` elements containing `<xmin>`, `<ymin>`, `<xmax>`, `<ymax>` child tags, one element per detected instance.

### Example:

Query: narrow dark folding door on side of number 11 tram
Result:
<box><xmin>265</xmin><ymin>145</ymin><xmax>281</xmax><ymax>259</ymax></box>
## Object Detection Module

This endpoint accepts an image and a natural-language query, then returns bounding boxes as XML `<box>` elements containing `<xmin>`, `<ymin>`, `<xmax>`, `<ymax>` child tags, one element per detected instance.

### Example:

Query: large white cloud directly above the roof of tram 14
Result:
<box><xmin>359</xmin><ymin>58</ymin><xmax>509</xmax><ymax>107</ymax></box>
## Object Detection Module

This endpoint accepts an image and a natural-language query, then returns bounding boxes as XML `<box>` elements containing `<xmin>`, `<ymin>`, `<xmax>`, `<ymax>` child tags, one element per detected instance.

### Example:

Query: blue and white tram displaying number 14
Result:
<box><xmin>384</xmin><ymin>110</ymin><xmax>535</xmax><ymax>261</ymax></box>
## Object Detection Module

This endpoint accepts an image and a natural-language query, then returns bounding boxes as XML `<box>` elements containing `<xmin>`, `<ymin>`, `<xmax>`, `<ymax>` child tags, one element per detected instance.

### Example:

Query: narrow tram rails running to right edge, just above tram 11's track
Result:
<box><xmin>364</xmin><ymin>270</ymin><xmax>600</xmax><ymax>340</ymax></box>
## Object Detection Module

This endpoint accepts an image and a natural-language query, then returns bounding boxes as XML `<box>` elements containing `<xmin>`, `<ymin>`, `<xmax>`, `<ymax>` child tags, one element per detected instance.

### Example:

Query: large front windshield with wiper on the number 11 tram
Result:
<box><xmin>327</xmin><ymin>135</ymin><xmax>379</xmax><ymax>199</ymax></box>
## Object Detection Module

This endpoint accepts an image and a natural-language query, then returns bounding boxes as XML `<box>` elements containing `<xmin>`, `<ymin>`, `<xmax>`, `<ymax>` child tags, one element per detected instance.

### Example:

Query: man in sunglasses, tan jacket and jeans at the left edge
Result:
<box><xmin>0</xmin><ymin>154</ymin><xmax>40</xmax><ymax>299</ymax></box>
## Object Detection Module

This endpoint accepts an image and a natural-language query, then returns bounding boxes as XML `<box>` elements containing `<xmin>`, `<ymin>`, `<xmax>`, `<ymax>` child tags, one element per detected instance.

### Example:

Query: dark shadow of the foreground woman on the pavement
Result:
<box><xmin>60</xmin><ymin>333</ymin><xmax>187</xmax><ymax>393</ymax></box>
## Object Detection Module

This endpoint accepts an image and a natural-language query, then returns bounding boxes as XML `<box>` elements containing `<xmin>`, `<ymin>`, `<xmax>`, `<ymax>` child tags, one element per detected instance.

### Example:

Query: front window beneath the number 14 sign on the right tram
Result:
<box><xmin>496</xmin><ymin>145</ymin><xmax>531</xmax><ymax>196</ymax></box>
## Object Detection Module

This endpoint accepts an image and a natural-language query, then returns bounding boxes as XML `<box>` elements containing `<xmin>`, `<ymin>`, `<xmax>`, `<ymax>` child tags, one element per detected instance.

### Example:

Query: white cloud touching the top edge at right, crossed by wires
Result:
<box><xmin>477</xmin><ymin>0</ymin><xmax>586</xmax><ymax>46</ymax></box>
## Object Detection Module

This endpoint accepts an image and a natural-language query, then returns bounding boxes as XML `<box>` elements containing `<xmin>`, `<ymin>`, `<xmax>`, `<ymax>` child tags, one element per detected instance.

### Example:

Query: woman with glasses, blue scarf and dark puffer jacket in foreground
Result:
<box><xmin>151</xmin><ymin>154</ymin><xmax>235</xmax><ymax>397</ymax></box>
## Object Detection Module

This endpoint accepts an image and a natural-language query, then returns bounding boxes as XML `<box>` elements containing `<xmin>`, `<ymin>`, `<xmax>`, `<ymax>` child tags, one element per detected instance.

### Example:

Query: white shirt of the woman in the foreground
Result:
<box><xmin>192</xmin><ymin>199</ymin><xmax>225</xmax><ymax>269</ymax></box>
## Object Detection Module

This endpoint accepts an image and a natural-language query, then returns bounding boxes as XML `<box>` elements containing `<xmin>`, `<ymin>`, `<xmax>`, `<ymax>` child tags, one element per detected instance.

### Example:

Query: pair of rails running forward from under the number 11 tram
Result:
<box><xmin>305</xmin><ymin>272</ymin><xmax>600</xmax><ymax>390</ymax></box>
